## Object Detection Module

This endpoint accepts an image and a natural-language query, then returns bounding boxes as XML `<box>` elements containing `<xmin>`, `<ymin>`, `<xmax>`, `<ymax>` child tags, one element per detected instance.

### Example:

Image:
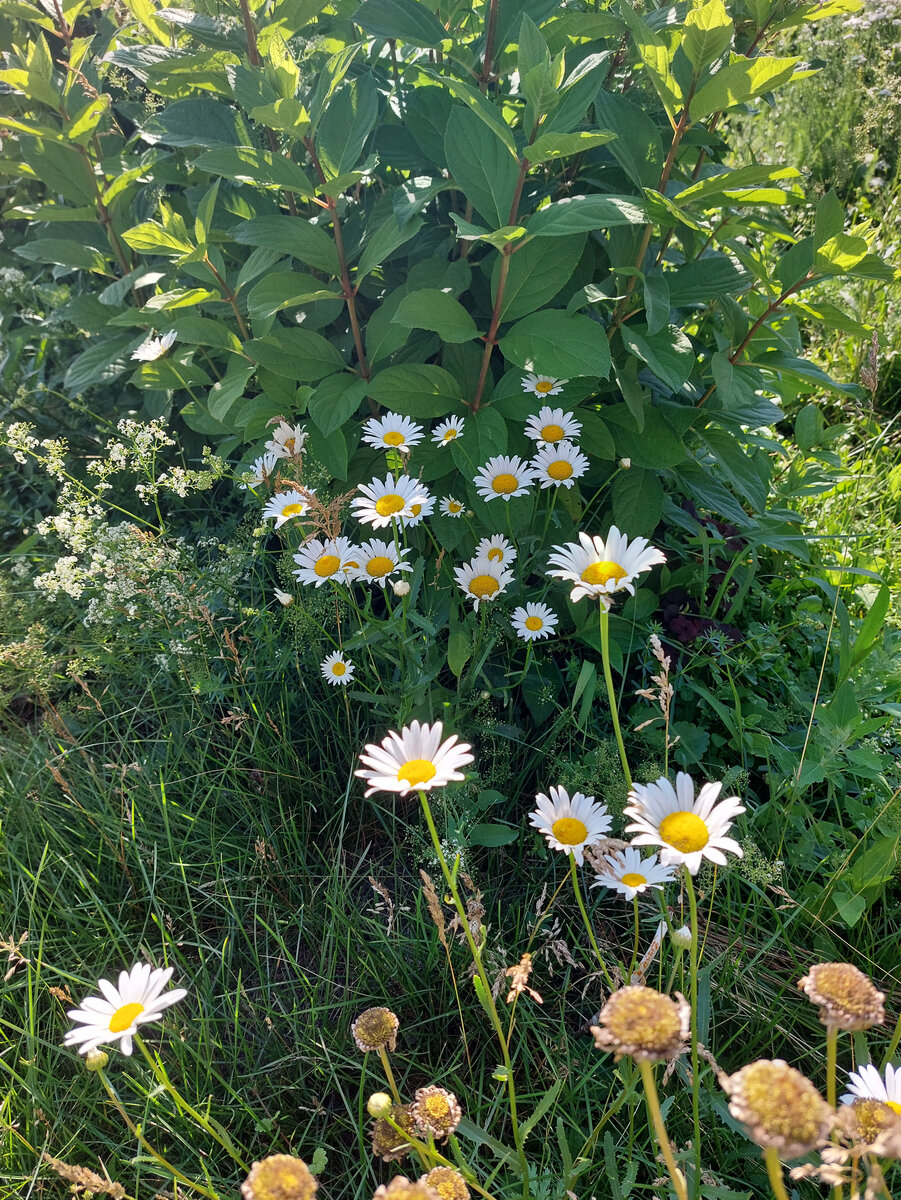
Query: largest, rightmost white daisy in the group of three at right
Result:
<box><xmin>623</xmin><ymin>770</ymin><xmax>745</xmax><ymax>875</ymax></box>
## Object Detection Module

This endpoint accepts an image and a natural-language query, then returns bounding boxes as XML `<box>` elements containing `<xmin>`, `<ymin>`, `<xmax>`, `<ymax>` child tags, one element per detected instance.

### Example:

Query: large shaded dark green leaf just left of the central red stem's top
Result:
<box><xmin>444</xmin><ymin>109</ymin><xmax>519</xmax><ymax>228</ymax></box>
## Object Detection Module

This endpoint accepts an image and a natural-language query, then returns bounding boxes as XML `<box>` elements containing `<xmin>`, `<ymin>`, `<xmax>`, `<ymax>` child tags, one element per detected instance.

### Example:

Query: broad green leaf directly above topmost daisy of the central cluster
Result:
<box><xmin>500</xmin><ymin>308</ymin><xmax>611</xmax><ymax>379</ymax></box>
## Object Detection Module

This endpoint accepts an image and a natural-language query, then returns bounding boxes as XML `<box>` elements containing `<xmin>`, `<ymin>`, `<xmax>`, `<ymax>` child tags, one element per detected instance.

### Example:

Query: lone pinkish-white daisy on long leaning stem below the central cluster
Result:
<box><xmin>354</xmin><ymin>721</ymin><xmax>474</xmax><ymax>796</ymax></box>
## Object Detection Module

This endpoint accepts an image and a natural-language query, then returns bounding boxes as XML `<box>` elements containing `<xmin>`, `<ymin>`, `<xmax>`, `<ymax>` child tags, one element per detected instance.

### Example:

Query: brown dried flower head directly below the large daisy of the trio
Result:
<box><xmin>591</xmin><ymin>986</ymin><xmax>691</xmax><ymax>1062</ymax></box>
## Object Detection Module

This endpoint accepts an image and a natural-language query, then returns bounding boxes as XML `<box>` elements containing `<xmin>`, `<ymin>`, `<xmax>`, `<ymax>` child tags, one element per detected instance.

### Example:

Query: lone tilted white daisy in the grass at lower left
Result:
<box><xmin>64</xmin><ymin>962</ymin><xmax>187</xmax><ymax>1055</ymax></box>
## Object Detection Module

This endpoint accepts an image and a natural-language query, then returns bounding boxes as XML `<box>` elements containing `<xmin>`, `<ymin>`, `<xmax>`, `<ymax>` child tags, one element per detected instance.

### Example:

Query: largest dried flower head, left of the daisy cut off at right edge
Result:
<box><xmin>720</xmin><ymin>1058</ymin><xmax>835</xmax><ymax>1158</ymax></box>
